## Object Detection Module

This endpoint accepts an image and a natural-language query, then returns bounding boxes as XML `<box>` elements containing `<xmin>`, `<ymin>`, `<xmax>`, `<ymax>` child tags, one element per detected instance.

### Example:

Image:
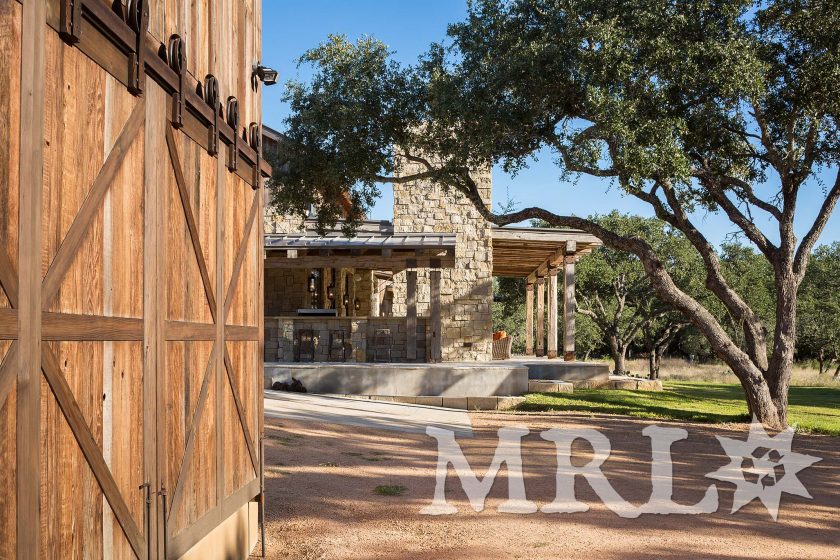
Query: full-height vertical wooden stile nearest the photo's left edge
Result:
<box><xmin>16</xmin><ymin>0</ymin><xmax>46</xmax><ymax>560</ymax></box>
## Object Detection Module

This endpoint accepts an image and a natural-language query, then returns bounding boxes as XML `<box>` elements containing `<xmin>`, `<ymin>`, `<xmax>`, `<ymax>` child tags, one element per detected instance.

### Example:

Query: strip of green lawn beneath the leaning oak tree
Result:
<box><xmin>518</xmin><ymin>381</ymin><xmax>840</xmax><ymax>435</ymax></box>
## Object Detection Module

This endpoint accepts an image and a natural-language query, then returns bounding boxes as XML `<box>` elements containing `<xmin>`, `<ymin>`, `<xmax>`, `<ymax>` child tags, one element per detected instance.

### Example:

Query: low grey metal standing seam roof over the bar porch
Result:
<box><xmin>265</xmin><ymin>233</ymin><xmax>455</xmax><ymax>249</ymax></box>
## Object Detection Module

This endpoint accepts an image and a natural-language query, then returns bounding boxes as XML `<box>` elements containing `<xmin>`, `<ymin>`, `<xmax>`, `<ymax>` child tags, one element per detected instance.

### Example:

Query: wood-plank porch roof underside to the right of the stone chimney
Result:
<box><xmin>492</xmin><ymin>227</ymin><xmax>601</xmax><ymax>278</ymax></box>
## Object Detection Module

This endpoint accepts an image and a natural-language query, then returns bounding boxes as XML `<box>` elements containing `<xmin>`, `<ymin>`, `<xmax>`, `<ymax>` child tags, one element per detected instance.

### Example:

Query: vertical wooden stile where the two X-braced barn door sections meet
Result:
<box><xmin>143</xmin><ymin>75</ymin><xmax>167</xmax><ymax>558</ymax></box>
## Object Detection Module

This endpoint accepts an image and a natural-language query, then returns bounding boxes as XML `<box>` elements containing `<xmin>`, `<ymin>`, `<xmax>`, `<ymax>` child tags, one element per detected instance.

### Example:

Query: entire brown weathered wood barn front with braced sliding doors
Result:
<box><xmin>0</xmin><ymin>0</ymin><xmax>265</xmax><ymax>560</ymax></box>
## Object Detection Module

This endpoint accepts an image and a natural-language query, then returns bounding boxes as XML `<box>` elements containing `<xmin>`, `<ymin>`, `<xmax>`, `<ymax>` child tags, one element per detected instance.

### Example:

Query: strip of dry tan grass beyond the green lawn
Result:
<box><xmin>627</xmin><ymin>358</ymin><xmax>840</xmax><ymax>387</ymax></box>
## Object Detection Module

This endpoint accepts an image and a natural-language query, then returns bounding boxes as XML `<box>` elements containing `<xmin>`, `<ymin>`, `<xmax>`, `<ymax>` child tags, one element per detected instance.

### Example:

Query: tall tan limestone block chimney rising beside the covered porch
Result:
<box><xmin>394</xmin><ymin>163</ymin><xmax>493</xmax><ymax>361</ymax></box>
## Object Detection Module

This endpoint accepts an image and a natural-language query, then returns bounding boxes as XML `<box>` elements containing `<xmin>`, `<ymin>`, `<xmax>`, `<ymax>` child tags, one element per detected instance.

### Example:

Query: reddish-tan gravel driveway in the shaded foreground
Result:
<box><xmin>266</xmin><ymin>414</ymin><xmax>840</xmax><ymax>560</ymax></box>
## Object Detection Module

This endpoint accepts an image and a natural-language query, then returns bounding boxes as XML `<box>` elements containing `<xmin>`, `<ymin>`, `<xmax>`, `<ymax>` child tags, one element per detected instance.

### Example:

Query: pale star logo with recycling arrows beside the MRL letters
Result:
<box><xmin>706</xmin><ymin>418</ymin><xmax>822</xmax><ymax>521</ymax></box>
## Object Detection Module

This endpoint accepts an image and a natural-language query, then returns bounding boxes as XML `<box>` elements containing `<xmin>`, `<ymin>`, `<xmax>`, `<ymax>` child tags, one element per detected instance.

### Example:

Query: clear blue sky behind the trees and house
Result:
<box><xmin>262</xmin><ymin>0</ymin><xmax>840</xmax><ymax>247</ymax></box>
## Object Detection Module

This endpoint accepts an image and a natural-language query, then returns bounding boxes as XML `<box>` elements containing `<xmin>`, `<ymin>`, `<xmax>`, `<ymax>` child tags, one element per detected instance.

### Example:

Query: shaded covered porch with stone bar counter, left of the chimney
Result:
<box><xmin>265</xmin><ymin>226</ymin><xmax>455</xmax><ymax>363</ymax></box>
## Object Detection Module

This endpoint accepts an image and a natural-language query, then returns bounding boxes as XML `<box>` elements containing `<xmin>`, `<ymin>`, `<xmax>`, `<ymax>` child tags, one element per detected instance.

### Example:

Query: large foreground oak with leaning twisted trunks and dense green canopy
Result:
<box><xmin>274</xmin><ymin>0</ymin><xmax>840</xmax><ymax>427</ymax></box>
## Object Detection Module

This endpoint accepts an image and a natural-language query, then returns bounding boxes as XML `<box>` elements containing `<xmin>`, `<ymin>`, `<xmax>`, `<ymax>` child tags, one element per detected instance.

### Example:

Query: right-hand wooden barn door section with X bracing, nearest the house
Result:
<box><xmin>155</xmin><ymin>87</ymin><xmax>262</xmax><ymax>558</ymax></box>
